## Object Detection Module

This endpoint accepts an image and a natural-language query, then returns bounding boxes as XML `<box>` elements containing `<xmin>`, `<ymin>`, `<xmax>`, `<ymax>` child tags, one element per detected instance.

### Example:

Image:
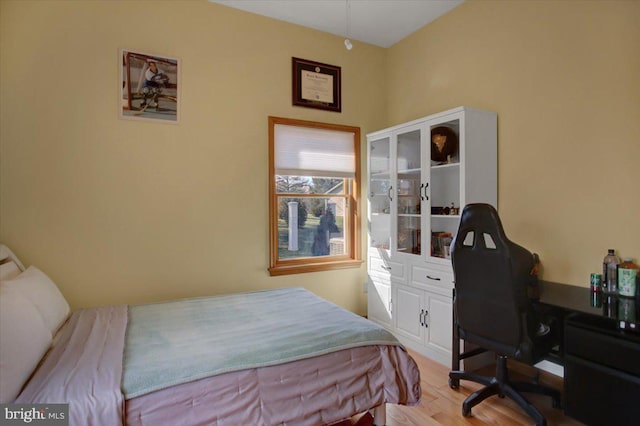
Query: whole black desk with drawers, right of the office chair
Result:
<box><xmin>536</xmin><ymin>281</ymin><xmax>640</xmax><ymax>426</ymax></box>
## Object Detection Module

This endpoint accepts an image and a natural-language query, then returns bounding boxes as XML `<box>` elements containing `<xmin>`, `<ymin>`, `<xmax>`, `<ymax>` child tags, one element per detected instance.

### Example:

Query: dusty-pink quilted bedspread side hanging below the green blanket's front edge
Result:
<box><xmin>125</xmin><ymin>345</ymin><xmax>421</xmax><ymax>426</ymax></box>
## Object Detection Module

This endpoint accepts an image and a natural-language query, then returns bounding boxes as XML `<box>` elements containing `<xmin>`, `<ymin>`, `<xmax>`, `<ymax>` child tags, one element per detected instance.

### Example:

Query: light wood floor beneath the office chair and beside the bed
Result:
<box><xmin>340</xmin><ymin>351</ymin><xmax>582</xmax><ymax>426</ymax></box>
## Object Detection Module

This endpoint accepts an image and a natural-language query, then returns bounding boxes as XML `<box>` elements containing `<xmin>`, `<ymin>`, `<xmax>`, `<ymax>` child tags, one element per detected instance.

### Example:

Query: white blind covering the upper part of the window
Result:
<box><xmin>274</xmin><ymin>124</ymin><xmax>356</xmax><ymax>178</ymax></box>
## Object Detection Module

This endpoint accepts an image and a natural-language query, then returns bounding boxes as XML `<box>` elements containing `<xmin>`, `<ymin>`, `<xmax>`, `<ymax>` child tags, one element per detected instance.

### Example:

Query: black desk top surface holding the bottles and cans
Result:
<box><xmin>538</xmin><ymin>281</ymin><xmax>640</xmax><ymax>333</ymax></box>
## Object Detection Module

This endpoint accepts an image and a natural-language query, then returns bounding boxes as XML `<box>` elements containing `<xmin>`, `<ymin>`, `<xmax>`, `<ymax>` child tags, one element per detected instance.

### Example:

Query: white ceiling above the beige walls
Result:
<box><xmin>209</xmin><ymin>0</ymin><xmax>463</xmax><ymax>47</ymax></box>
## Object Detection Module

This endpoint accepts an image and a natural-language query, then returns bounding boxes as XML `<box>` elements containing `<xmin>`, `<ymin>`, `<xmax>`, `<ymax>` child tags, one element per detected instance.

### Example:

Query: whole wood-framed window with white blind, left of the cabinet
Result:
<box><xmin>269</xmin><ymin>117</ymin><xmax>362</xmax><ymax>275</ymax></box>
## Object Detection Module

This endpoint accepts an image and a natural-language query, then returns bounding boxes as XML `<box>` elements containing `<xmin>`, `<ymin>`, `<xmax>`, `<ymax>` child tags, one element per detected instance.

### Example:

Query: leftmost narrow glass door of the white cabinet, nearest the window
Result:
<box><xmin>369</xmin><ymin>137</ymin><xmax>393</xmax><ymax>250</ymax></box>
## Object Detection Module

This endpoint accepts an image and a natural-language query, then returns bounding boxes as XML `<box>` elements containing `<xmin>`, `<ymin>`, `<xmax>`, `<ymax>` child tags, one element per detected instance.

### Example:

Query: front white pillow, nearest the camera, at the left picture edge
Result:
<box><xmin>0</xmin><ymin>283</ymin><xmax>51</xmax><ymax>403</ymax></box>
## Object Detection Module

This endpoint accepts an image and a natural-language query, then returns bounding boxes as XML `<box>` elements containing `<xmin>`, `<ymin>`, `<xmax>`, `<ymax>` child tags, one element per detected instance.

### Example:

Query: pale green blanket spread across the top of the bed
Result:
<box><xmin>122</xmin><ymin>288</ymin><xmax>399</xmax><ymax>399</ymax></box>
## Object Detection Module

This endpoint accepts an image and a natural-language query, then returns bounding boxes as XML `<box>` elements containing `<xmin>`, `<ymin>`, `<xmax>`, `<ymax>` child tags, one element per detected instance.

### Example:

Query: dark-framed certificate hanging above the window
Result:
<box><xmin>291</xmin><ymin>58</ymin><xmax>342</xmax><ymax>112</ymax></box>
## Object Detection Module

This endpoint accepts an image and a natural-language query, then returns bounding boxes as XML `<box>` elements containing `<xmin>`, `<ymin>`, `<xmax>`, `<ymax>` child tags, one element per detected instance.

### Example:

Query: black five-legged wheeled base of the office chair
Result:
<box><xmin>449</xmin><ymin>356</ymin><xmax>561</xmax><ymax>426</ymax></box>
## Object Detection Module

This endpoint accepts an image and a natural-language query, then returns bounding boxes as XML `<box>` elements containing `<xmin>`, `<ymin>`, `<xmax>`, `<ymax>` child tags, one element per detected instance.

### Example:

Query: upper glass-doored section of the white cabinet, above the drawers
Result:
<box><xmin>367</xmin><ymin>107</ymin><xmax>497</xmax><ymax>267</ymax></box>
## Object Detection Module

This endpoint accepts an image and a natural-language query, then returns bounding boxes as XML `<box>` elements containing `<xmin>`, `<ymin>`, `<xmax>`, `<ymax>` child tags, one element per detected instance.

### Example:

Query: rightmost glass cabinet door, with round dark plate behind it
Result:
<box><xmin>427</xmin><ymin>116</ymin><xmax>462</xmax><ymax>262</ymax></box>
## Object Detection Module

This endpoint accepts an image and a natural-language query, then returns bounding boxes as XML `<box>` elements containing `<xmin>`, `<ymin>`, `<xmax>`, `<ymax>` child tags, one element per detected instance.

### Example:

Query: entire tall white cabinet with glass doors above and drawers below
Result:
<box><xmin>367</xmin><ymin>107</ymin><xmax>497</xmax><ymax>364</ymax></box>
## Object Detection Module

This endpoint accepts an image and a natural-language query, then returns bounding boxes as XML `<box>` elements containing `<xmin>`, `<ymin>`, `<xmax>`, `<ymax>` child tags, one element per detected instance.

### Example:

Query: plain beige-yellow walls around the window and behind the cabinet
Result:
<box><xmin>0</xmin><ymin>0</ymin><xmax>640</xmax><ymax>313</ymax></box>
